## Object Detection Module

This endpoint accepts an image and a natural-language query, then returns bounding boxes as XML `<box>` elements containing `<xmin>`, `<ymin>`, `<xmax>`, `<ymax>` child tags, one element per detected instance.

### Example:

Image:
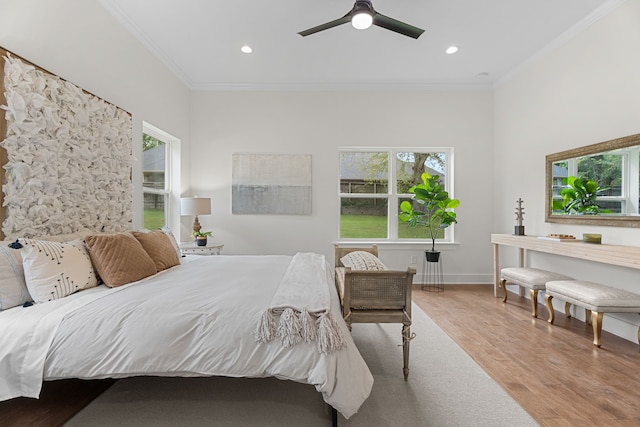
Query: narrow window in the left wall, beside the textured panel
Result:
<box><xmin>142</xmin><ymin>123</ymin><xmax>175</xmax><ymax>230</ymax></box>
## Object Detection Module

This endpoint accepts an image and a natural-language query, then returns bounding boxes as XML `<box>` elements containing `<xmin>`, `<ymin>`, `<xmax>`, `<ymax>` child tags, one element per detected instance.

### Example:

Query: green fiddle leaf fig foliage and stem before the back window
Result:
<box><xmin>399</xmin><ymin>172</ymin><xmax>460</xmax><ymax>252</ymax></box>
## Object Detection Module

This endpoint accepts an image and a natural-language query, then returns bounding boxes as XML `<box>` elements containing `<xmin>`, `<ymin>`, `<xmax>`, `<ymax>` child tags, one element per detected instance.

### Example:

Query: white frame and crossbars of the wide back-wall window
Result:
<box><xmin>337</xmin><ymin>146</ymin><xmax>455</xmax><ymax>245</ymax></box>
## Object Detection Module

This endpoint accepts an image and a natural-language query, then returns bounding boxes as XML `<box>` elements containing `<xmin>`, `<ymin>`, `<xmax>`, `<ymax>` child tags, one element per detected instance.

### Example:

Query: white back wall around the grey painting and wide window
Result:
<box><xmin>191</xmin><ymin>92</ymin><xmax>496</xmax><ymax>283</ymax></box>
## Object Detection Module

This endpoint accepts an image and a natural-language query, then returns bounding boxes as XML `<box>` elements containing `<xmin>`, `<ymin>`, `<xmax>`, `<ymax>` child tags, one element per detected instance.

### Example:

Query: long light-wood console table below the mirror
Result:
<box><xmin>491</xmin><ymin>234</ymin><xmax>640</xmax><ymax>297</ymax></box>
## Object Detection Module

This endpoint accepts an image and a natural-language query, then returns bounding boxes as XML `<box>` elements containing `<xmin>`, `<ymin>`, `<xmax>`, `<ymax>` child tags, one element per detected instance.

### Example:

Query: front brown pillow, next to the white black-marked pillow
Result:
<box><xmin>85</xmin><ymin>233</ymin><xmax>157</xmax><ymax>287</ymax></box>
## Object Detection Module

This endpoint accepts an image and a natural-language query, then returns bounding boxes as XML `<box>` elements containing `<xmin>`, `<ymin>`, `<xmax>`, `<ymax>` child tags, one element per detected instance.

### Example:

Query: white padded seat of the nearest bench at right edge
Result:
<box><xmin>547</xmin><ymin>280</ymin><xmax>640</xmax><ymax>313</ymax></box>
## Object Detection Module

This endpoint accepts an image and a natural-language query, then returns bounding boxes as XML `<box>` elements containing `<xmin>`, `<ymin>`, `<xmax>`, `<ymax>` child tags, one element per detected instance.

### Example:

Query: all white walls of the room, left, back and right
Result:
<box><xmin>11</xmin><ymin>0</ymin><xmax>640</xmax><ymax>339</ymax></box>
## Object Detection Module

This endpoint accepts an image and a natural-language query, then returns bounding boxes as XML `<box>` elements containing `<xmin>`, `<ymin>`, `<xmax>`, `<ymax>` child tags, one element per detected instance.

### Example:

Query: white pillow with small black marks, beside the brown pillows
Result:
<box><xmin>21</xmin><ymin>239</ymin><xmax>98</xmax><ymax>303</ymax></box>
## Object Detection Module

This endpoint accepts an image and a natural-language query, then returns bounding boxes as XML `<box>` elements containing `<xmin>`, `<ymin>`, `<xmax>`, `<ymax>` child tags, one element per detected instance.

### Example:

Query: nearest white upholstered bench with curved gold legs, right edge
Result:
<box><xmin>544</xmin><ymin>280</ymin><xmax>640</xmax><ymax>347</ymax></box>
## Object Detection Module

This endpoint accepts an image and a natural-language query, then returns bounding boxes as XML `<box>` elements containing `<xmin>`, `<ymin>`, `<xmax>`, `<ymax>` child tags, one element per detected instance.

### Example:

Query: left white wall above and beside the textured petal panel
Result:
<box><xmin>0</xmin><ymin>0</ymin><xmax>190</xmax><ymax>236</ymax></box>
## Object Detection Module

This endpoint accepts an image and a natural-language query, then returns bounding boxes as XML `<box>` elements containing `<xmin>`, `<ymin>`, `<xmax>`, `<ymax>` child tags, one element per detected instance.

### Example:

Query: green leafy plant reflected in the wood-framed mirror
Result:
<box><xmin>553</xmin><ymin>176</ymin><xmax>611</xmax><ymax>215</ymax></box>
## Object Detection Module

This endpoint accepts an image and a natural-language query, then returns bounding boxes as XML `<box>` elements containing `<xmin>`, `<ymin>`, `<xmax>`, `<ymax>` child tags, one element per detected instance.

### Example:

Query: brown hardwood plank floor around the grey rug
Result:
<box><xmin>0</xmin><ymin>285</ymin><xmax>640</xmax><ymax>427</ymax></box>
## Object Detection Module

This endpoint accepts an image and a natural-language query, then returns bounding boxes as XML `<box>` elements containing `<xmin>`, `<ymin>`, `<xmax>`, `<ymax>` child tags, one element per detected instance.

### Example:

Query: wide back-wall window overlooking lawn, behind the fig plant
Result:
<box><xmin>339</xmin><ymin>147</ymin><xmax>453</xmax><ymax>242</ymax></box>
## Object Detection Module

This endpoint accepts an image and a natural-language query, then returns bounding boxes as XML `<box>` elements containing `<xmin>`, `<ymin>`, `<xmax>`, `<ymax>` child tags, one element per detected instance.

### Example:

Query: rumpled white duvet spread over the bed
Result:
<box><xmin>0</xmin><ymin>255</ymin><xmax>373</xmax><ymax>418</ymax></box>
